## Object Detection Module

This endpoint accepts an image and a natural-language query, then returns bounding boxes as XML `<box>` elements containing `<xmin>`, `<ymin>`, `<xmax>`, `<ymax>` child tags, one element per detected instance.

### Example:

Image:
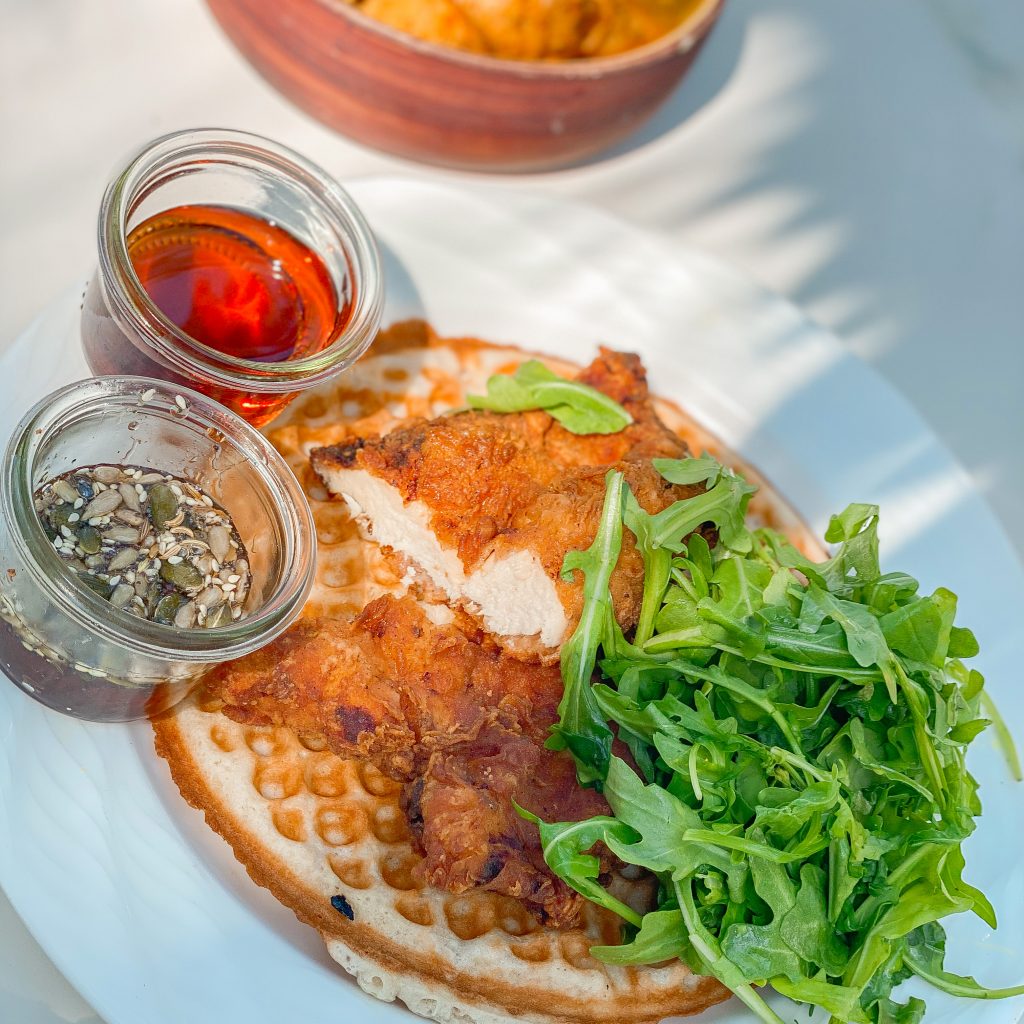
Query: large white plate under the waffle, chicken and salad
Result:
<box><xmin>0</xmin><ymin>180</ymin><xmax>1024</xmax><ymax>1024</ymax></box>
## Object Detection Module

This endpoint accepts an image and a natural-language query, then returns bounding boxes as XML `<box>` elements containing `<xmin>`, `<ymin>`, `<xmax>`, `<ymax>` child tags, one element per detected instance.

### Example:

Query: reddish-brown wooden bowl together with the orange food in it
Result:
<box><xmin>208</xmin><ymin>0</ymin><xmax>724</xmax><ymax>171</ymax></box>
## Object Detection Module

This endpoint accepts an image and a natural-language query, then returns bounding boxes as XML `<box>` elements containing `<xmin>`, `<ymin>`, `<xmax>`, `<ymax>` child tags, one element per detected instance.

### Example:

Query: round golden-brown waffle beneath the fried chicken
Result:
<box><xmin>154</xmin><ymin>322</ymin><xmax>811</xmax><ymax>1024</ymax></box>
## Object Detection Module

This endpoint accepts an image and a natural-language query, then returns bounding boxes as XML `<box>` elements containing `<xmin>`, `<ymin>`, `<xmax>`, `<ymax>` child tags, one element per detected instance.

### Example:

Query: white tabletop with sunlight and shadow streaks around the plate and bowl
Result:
<box><xmin>0</xmin><ymin>0</ymin><xmax>1024</xmax><ymax>1024</ymax></box>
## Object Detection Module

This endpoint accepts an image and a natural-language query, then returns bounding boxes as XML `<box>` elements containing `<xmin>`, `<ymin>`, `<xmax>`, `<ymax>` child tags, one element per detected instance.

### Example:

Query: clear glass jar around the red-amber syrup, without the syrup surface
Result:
<box><xmin>82</xmin><ymin>129</ymin><xmax>384</xmax><ymax>427</ymax></box>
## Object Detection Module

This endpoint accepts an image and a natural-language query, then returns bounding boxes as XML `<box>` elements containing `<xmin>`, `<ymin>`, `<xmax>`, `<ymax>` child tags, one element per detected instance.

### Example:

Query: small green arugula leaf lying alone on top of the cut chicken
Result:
<box><xmin>466</xmin><ymin>359</ymin><xmax>633</xmax><ymax>434</ymax></box>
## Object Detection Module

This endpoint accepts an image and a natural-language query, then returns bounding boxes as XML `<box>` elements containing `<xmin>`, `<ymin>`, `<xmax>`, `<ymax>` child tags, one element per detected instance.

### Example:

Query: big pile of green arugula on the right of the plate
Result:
<box><xmin>522</xmin><ymin>458</ymin><xmax>1024</xmax><ymax>1024</ymax></box>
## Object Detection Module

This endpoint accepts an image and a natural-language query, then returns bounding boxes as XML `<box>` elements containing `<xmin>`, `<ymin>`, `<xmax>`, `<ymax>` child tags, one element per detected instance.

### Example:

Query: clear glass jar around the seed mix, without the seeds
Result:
<box><xmin>0</xmin><ymin>377</ymin><xmax>316</xmax><ymax>722</ymax></box>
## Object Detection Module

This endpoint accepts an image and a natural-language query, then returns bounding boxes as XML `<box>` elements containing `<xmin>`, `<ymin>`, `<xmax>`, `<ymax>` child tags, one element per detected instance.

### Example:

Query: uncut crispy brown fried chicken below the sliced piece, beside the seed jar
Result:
<box><xmin>206</xmin><ymin>596</ymin><xmax>608</xmax><ymax>926</ymax></box>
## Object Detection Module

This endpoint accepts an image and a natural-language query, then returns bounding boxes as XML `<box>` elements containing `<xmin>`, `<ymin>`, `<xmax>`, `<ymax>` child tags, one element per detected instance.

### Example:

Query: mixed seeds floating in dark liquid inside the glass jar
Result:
<box><xmin>35</xmin><ymin>466</ymin><xmax>252</xmax><ymax>629</ymax></box>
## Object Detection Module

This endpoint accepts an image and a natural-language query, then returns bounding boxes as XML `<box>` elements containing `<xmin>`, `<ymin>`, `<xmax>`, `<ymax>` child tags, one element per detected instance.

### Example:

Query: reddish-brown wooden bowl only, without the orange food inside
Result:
<box><xmin>207</xmin><ymin>0</ymin><xmax>724</xmax><ymax>171</ymax></box>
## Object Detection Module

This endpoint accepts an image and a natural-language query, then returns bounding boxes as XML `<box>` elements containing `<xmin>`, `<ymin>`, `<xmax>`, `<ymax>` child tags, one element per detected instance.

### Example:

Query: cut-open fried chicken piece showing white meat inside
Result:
<box><xmin>310</xmin><ymin>349</ymin><xmax>699</xmax><ymax>664</ymax></box>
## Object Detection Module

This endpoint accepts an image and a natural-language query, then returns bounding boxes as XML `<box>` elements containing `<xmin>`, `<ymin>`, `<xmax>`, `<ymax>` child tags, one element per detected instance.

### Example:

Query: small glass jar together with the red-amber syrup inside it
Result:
<box><xmin>82</xmin><ymin>129</ymin><xmax>383</xmax><ymax>426</ymax></box>
